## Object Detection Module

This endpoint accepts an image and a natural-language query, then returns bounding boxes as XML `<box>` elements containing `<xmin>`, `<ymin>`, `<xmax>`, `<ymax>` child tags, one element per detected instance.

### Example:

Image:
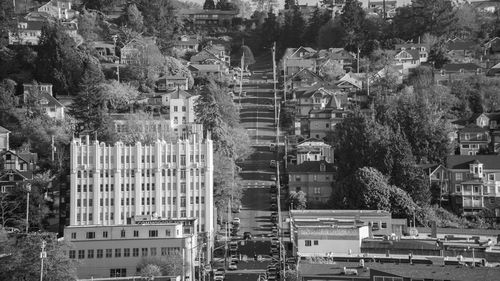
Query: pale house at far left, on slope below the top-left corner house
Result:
<box><xmin>9</xmin><ymin>19</ymin><xmax>45</xmax><ymax>46</ymax></box>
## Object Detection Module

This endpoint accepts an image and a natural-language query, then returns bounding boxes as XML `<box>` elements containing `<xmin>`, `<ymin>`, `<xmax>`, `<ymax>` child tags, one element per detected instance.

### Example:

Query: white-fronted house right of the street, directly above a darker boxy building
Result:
<box><xmin>297</xmin><ymin>138</ymin><xmax>333</xmax><ymax>165</ymax></box>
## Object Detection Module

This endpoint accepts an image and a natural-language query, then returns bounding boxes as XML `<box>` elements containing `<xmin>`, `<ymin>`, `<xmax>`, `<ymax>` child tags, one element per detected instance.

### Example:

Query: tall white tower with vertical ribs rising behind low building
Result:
<box><xmin>70</xmin><ymin>134</ymin><xmax>214</xmax><ymax>233</ymax></box>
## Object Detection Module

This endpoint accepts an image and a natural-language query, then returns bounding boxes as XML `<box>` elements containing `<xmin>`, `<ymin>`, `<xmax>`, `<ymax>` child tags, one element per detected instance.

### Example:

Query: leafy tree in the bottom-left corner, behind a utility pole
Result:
<box><xmin>0</xmin><ymin>232</ymin><xmax>77</xmax><ymax>281</ymax></box>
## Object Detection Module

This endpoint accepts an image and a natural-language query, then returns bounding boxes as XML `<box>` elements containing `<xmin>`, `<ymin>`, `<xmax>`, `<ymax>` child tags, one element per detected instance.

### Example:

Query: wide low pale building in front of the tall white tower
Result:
<box><xmin>64</xmin><ymin>221</ymin><xmax>198</xmax><ymax>280</ymax></box>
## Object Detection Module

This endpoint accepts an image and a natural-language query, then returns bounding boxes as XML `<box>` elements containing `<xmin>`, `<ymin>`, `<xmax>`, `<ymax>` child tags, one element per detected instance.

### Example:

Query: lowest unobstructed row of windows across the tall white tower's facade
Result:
<box><xmin>76</xmin><ymin>196</ymin><xmax>205</xmax><ymax>207</ymax></box>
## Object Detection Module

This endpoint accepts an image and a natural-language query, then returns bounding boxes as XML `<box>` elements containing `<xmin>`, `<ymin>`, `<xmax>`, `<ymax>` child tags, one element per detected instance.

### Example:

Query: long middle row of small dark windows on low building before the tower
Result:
<box><xmin>69</xmin><ymin>247</ymin><xmax>181</xmax><ymax>259</ymax></box>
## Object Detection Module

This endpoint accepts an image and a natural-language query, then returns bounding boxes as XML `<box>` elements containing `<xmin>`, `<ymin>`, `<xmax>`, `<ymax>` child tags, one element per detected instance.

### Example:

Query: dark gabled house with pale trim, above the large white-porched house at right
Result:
<box><xmin>458</xmin><ymin>125</ymin><xmax>491</xmax><ymax>155</ymax></box>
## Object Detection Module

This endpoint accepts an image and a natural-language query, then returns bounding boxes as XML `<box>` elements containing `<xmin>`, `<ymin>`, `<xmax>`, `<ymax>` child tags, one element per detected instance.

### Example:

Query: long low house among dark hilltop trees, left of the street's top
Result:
<box><xmin>179</xmin><ymin>9</ymin><xmax>239</xmax><ymax>27</ymax></box>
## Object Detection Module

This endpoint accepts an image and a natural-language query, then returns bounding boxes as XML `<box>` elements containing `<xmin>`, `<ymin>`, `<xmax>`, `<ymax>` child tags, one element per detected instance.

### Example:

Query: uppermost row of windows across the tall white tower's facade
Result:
<box><xmin>77</xmin><ymin>153</ymin><xmax>205</xmax><ymax>166</ymax></box>
